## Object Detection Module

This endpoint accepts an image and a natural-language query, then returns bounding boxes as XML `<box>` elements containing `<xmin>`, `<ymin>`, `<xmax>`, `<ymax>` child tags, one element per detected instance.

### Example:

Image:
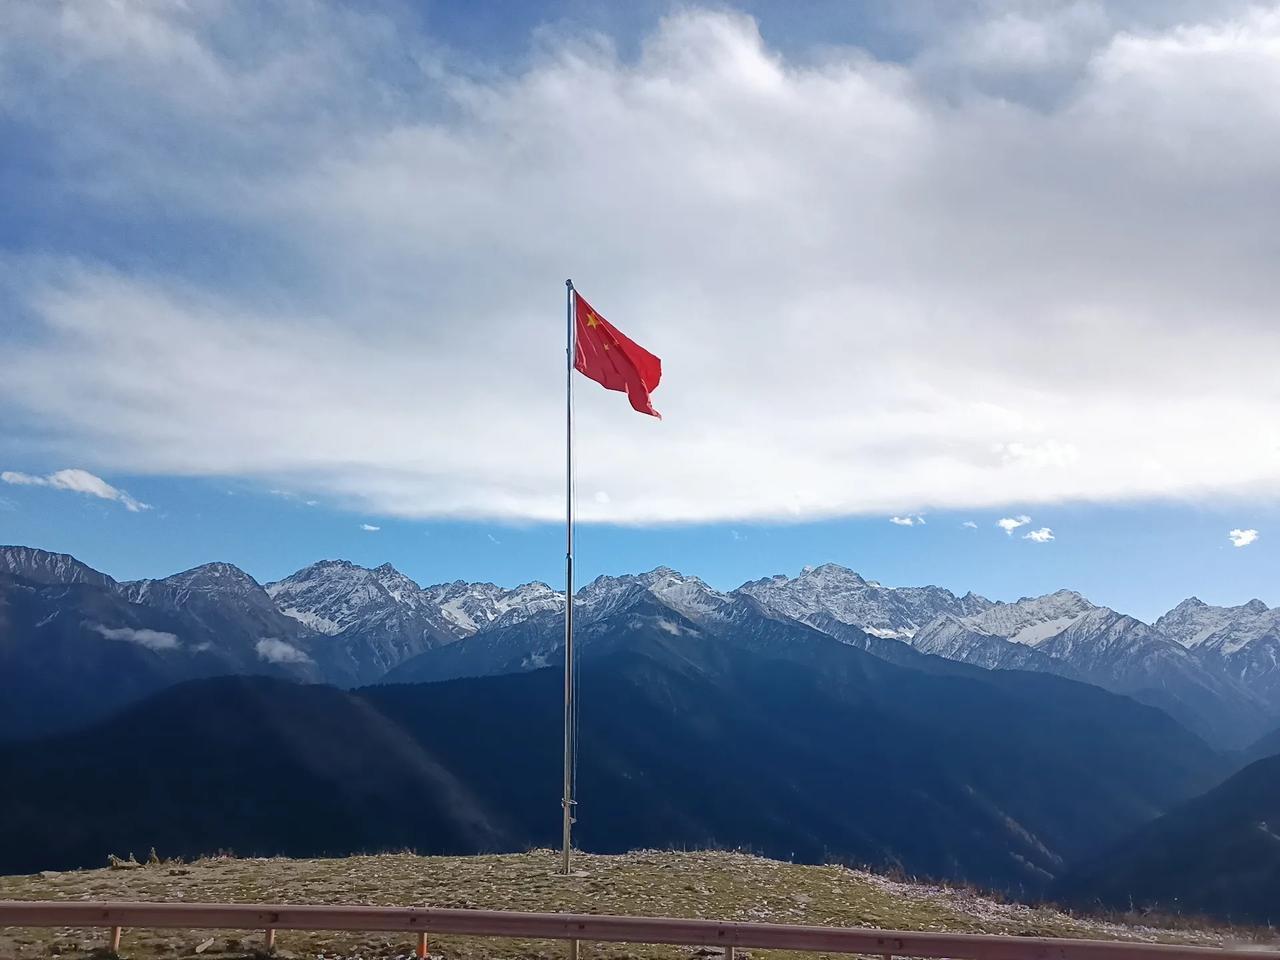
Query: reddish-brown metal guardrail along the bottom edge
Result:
<box><xmin>0</xmin><ymin>900</ymin><xmax>1280</xmax><ymax>960</ymax></box>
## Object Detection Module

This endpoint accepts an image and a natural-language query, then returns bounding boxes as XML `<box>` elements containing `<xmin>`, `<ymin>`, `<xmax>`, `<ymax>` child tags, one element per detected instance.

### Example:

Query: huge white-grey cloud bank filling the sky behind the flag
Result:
<box><xmin>0</xmin><ymin>3</ymin><xmax>1280</xmax><ymax>522</ymax></box>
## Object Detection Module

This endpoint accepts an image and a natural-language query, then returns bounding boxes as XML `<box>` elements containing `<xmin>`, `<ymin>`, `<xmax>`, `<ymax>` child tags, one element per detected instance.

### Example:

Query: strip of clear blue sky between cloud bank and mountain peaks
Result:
<box><xmin>0</xmin><ymin>477</ymin><xmax>1280</xmax><ymax>620</ymax></box>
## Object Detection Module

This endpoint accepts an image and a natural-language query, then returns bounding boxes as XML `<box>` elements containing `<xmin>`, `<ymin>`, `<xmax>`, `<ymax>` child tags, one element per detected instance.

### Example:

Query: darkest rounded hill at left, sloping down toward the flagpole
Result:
<box><xmin>0</xmin><ymin>677</ymin><xmax>515</xmax><ymax>872</ymax></box>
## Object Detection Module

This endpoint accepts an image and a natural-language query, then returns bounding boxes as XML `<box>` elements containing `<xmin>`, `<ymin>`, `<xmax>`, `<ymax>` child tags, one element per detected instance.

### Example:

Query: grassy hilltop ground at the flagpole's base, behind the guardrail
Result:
<box><xmin>0</xmin><ymin>850</ymin><xmax>1261</xmax><ymax>960</ymax></box>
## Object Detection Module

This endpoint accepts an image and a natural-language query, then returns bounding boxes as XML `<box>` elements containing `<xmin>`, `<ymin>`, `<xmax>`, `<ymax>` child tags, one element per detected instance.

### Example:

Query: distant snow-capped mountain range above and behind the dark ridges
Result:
<box><xmin>0</xmin><ymin>547</ymin><xmax>1280</xmax><ymax>749</ymax></box>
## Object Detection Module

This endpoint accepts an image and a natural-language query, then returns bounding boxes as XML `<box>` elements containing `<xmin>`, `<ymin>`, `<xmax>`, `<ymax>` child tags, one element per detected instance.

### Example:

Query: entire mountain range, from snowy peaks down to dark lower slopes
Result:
<box><xmin>0</xmin><ymin>547</ymin><xmax>1280</xmax><ymax>916</ymax></box>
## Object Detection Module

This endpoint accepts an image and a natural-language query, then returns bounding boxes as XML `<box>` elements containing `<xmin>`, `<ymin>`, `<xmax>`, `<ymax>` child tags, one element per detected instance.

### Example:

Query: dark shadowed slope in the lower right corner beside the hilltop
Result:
<box><xmin>1053</xmin><ymin>756</ymin><xmax>1280</xmax><ymax>925</ymax></box>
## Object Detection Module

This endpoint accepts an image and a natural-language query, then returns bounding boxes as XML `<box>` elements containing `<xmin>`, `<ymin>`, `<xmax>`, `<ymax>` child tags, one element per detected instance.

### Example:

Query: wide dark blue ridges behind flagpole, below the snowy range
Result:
<box><xmin>0</xmin><ymin>616</ymin><xmax>1216</xmax><ymax>888</ymax></box>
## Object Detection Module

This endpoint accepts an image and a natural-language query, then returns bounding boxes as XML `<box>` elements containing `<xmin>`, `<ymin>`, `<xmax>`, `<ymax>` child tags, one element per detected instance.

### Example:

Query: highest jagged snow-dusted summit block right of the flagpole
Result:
<box><xmin>735</xmin><ymin>563</ymin><xmax>992</xmax><ymax>640</ymax></box>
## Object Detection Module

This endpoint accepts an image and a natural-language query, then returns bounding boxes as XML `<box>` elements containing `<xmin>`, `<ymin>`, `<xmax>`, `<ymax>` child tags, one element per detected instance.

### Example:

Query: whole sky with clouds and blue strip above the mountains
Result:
<box><xmin>0</xmin><ymin>0</ymin><xmax>1280</xmax><ymax>618</ymax></box>
